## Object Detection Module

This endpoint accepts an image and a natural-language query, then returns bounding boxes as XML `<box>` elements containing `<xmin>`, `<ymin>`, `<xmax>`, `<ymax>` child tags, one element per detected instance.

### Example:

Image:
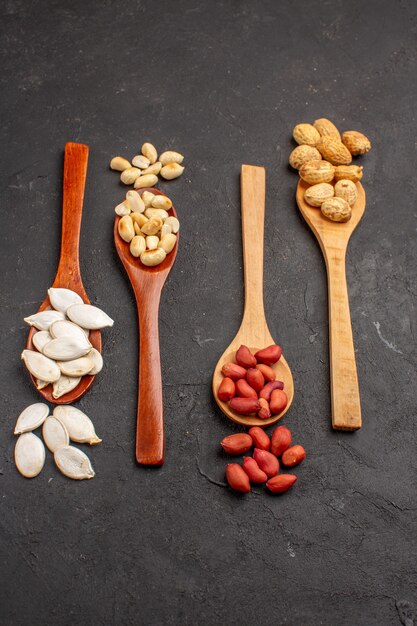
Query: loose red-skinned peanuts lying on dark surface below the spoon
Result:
<box><xmin>220</xmin><ymin>426</ymin><xmax>306</xmax><ymax>493</ymax></box>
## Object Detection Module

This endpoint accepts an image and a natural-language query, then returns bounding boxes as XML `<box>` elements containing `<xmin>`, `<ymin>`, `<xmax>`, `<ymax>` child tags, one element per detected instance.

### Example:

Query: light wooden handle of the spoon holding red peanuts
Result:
<box><xmin>240</xmin><ymin>165</ymin><xmax>265</xmax><ymax>345</ymax></box>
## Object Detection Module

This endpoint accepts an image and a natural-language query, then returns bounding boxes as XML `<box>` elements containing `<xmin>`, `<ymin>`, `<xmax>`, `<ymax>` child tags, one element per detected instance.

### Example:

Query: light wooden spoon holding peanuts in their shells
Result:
<box><xmin>296</xmin><ymin>180</ymin><xmax>366</xmax><ymax>430</ymax></box>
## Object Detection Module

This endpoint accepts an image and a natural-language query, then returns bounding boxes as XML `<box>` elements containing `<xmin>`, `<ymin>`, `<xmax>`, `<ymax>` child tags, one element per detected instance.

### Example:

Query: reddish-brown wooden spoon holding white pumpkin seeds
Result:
<box><xmin>26</xmin><ymin>143</ymin><xmax>101</xmax><ymax>404</ymax></box>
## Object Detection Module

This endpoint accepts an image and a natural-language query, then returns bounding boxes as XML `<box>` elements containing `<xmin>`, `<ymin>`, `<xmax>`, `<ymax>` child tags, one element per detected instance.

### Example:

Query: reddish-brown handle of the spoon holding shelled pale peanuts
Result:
<box><xmin>136</xmin><ymin>276</ymin><xmax>164</xmax><ymax>465</ymax></box>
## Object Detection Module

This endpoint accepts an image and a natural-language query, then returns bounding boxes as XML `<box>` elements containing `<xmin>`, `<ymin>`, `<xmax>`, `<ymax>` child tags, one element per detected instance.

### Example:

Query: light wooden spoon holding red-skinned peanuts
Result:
<box><xmin>213</xmin><ymin>165</ymin><xmax>294</xmax><ymax>427</ymax></box>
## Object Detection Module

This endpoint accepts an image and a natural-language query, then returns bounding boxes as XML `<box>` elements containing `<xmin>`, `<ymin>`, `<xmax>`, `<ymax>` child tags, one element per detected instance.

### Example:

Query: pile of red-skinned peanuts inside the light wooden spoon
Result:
<box><xmin>217</xmin><ymin>344</ymin><xmax>288</xmax><ymax>419</ymax></box>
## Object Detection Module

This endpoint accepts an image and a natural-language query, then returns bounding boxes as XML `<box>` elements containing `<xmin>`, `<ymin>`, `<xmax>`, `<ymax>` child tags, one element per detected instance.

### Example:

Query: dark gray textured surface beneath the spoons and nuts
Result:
<box><xmin>0</xmin><ymin>0</ymin><xmax>417</xmax><ymax>626</ymax></box>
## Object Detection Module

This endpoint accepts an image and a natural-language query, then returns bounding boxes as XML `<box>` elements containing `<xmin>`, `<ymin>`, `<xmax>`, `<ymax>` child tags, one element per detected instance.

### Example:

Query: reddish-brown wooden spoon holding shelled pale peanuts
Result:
<box><xmin>114</xmin><ymin>188</ymin><xmax>178</xmax><ymax>465</ymax></box>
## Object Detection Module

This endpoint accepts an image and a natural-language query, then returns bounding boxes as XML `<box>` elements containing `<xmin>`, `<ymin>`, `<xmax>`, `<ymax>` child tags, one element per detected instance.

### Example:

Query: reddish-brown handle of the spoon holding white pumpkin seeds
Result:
<box><xmin>54</xmin><ymin>143</ymin><xmax>88</xmax><ymax>288</ymax></box>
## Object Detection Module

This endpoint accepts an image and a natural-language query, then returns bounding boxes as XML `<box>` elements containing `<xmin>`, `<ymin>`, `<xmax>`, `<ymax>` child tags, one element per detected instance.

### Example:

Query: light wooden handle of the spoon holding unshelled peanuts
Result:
<box><xmin>327</xmin><ymin>248</ymin><xmax>362</xmax><ymax>430</ymax></box>
